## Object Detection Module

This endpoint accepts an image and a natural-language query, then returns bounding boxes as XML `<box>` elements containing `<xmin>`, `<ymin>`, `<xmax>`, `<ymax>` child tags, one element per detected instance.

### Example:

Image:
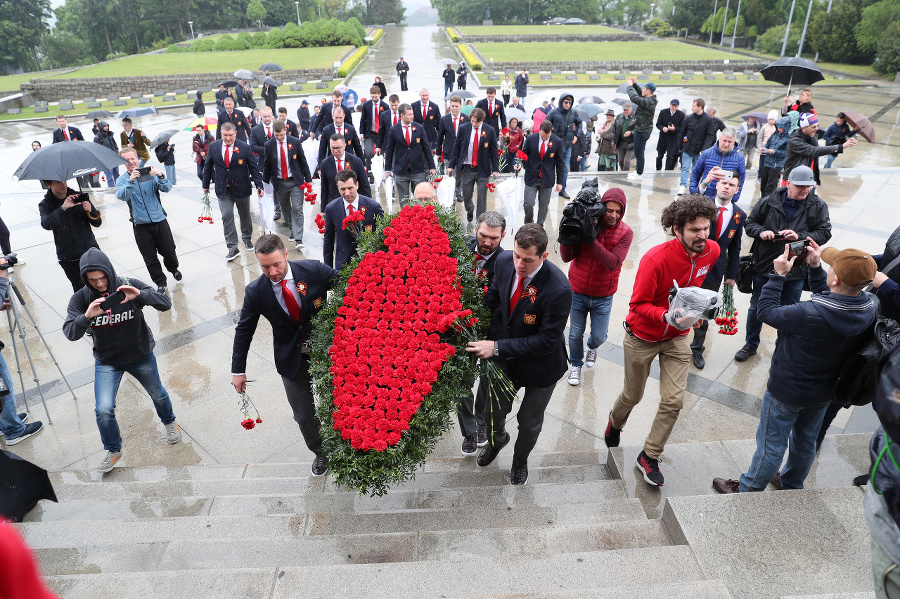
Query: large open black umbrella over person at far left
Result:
<box><xmin>13</xmin><ymin>141</ymin><xmax>125</xmax><ymax>181</ymax></box>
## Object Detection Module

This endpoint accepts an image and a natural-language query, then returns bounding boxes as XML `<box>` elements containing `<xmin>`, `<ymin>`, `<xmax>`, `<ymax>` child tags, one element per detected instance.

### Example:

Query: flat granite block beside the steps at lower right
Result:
<box><xmin>663</xmin><ymin>487</ymin><xmax>872</xmax><ymax>598</ymax></box>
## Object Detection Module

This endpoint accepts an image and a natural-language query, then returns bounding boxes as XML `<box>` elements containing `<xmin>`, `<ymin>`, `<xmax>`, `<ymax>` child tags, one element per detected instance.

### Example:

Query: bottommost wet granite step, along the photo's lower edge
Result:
<box><xmin>47</xmin><ymin>547</ymin><xmax>703</xmax><ymax>599</ymax></box>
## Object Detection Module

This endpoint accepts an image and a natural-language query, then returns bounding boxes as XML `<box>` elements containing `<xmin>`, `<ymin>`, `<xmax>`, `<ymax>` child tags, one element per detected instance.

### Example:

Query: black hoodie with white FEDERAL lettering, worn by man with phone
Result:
<box><xmin>63</xmin><ymin>248</ymin><xmax>171</xmax><ymax>372</ymax></box>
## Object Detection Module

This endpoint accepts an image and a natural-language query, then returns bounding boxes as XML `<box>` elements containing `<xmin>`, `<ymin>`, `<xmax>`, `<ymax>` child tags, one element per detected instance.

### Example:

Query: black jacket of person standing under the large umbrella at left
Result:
<box><xmin>38</xmin><ymin>188</ymin><xmax>101</xmax><ymax>260</ymax></box>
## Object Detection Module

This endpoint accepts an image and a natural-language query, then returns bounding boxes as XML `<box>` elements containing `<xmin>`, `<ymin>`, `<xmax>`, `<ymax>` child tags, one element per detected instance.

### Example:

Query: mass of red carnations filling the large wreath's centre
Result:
<box><xmin>329</xmin><ymin>205</ymin><xmax>460</xmax><ymax>451</ymax></box>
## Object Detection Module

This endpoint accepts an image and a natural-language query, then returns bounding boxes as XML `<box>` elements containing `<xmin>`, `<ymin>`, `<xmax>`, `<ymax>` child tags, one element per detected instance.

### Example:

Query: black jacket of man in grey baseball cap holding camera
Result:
<box><xmin>744</xmin><ymin>187</ymin><xmax>831</xmax><ymax>280</ymax></box>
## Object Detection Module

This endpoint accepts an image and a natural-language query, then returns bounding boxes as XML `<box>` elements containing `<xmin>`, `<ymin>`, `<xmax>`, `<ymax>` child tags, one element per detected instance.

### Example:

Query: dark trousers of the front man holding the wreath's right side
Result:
<box><xmin>484</xmin><ymin>366</ymin><xmax>556</xmax><ymax>468</ymax></box>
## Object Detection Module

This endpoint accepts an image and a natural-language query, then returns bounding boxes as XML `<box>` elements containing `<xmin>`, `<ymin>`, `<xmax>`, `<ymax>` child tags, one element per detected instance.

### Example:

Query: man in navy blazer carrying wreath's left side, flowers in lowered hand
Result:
<box><xmin>231</xmin><ymin>235</ymin><xmax>339</xmax><ymax>476</ymax></box>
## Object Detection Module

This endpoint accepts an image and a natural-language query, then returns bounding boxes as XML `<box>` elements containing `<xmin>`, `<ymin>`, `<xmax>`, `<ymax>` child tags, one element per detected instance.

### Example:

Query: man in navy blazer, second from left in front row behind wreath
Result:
<box><xmin>263</xmin><ymin>121</ymin><xmax>312</xmax><ymax>250</ymax></box>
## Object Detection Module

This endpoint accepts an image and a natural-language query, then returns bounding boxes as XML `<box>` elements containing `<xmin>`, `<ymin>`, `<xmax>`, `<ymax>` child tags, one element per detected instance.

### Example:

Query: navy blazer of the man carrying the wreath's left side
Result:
<box><xmin>231</xmin><ymin>260</ymin><xmax>339</xmax><ymax>378</ymax></box>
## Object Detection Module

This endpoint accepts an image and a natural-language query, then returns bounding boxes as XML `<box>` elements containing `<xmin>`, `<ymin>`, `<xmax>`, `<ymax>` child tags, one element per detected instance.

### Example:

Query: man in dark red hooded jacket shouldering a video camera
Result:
<box><xmin>559</xmin><ymin>187</ymin><xmax>634</xmax><ymax>385</ymax></box>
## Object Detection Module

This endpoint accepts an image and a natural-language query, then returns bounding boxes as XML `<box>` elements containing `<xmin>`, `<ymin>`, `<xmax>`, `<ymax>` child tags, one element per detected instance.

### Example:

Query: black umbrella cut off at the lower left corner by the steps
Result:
<box><xmin>0</xmin><ymin>448</ymin><xmax>57</xmax><ymax>522</ymax></box>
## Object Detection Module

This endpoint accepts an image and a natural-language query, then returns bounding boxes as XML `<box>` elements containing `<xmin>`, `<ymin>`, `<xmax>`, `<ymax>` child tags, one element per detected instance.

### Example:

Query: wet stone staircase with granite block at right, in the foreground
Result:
<box><xmin>15</xmin><ymin>435</ymin><xmax>873</xmax><ymax>599</ymax></box>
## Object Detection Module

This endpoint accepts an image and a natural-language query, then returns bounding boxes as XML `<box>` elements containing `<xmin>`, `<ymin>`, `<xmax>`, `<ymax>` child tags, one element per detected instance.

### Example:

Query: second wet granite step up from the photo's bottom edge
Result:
<box><xmin>31</xmin><ymin>520</ymin><xmax>671</xmax><ymax>575</ymax></box>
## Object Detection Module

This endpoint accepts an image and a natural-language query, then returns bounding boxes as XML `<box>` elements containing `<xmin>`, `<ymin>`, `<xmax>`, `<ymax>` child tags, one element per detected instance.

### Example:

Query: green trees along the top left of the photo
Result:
<box><xmin>0</xmin><ymin>0</ymin><xmax>405</xmax><ymax>74</ymax></box>
